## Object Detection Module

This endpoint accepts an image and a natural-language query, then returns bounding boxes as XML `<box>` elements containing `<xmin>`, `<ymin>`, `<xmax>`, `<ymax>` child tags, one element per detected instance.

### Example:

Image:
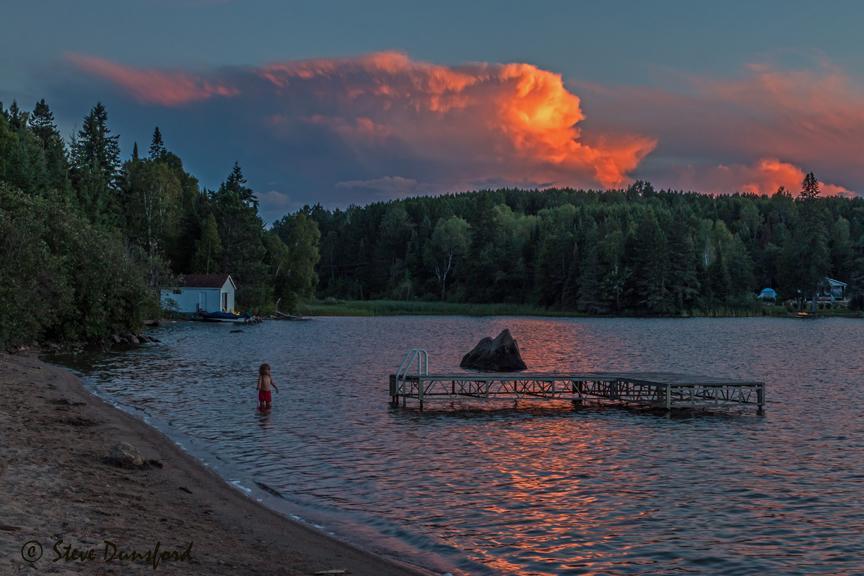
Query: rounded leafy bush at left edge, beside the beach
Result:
<box><xmin>0</xmin><ymin>183</ymin><xmax>157</xmax><ymax>347</ymax></box>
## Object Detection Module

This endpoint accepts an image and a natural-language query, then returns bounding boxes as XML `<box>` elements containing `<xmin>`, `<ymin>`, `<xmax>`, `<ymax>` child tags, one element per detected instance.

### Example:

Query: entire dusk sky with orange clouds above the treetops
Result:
<box><xmin>0</xmin><ymin>0</ymin><xmax>864</xmax><ymax>220</ymax></box>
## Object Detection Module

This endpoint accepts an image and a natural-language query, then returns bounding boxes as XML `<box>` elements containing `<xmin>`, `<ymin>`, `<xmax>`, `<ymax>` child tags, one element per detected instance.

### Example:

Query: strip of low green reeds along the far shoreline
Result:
<box><xmin>298</xmin><ymin>299</ymin><xmax>864</xmax><ymax>318</ymax></box>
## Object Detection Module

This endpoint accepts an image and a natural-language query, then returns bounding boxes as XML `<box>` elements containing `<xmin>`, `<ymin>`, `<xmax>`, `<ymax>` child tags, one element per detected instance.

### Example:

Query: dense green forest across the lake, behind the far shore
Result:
<box><xmin>303</xmin><ymin>181</ymin><xmax>864</xmax><ymax>314</ymax></box>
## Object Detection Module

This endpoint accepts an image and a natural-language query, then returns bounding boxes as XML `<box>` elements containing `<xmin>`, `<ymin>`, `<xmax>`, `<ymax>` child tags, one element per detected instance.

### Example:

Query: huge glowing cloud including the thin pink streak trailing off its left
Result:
<box><xmin>70</xmin><ymin>52</ymin><xmax>656</xmax><ymax>187</ymax></box>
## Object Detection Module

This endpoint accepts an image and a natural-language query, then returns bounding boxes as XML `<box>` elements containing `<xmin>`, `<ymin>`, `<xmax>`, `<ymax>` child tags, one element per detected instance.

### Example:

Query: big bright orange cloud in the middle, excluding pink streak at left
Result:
<box><xmin>258</xmin><ymin>52</ymin><xmax>656</xmax><ymax>187</ymax></box>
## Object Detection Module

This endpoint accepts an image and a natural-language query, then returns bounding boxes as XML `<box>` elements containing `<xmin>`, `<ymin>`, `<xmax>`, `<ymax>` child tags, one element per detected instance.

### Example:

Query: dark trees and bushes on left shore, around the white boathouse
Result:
<box><xmin>0</xmin><ymin>100</ymin><xmax>319</xmax><ymax>346</ymax></box>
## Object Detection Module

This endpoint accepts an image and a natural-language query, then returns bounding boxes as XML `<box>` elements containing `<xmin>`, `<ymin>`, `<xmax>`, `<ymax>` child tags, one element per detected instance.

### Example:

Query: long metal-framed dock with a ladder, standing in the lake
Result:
<box><xmin>390</xmin><ymin>349</ymin><xmax>765</xmax><ymax>415</ymax></box>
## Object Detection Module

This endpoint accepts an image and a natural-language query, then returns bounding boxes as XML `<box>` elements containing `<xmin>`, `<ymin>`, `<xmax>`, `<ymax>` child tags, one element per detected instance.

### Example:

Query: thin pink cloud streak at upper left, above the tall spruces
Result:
<box><xmin>66</xmin><ymin>54</ymin><xmax>238</xmax><ymax>106</ymax></box>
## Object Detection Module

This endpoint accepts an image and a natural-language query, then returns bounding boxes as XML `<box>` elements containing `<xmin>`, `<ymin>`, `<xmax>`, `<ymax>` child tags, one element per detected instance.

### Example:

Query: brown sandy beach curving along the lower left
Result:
<box><xmin>0</xmin><ymin>354</ymin><xmax>425</xmax><ymax>576</ymax></box>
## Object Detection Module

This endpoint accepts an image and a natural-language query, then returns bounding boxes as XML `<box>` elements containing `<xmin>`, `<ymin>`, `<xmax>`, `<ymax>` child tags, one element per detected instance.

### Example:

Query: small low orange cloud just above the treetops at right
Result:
<box><xmin>678</xmin><ymin>158</ymin><xmax>853</xmax><ymax>196</ymax></box>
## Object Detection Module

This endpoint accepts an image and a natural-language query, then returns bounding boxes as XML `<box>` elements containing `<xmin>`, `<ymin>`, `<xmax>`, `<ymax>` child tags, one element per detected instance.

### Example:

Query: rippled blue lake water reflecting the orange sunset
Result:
<box><xmin>62</xmin><ymin>317</ymin><xmax>864</xmax><ymax>574</ymax></box>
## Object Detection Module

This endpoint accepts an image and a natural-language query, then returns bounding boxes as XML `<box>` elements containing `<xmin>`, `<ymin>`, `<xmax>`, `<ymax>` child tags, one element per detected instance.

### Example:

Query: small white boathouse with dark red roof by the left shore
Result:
<box><xmin>160</xmin><ymin>274</ymin><xmax>237</xmax><ymax>314</ymax></box>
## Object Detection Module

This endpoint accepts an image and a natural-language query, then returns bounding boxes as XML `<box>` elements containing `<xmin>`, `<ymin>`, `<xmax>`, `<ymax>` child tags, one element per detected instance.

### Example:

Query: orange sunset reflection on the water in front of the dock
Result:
<box><xmin>432</xmin><ymin>412</ymin><xmax>652</xmax><ymax>575</ymax></box>
